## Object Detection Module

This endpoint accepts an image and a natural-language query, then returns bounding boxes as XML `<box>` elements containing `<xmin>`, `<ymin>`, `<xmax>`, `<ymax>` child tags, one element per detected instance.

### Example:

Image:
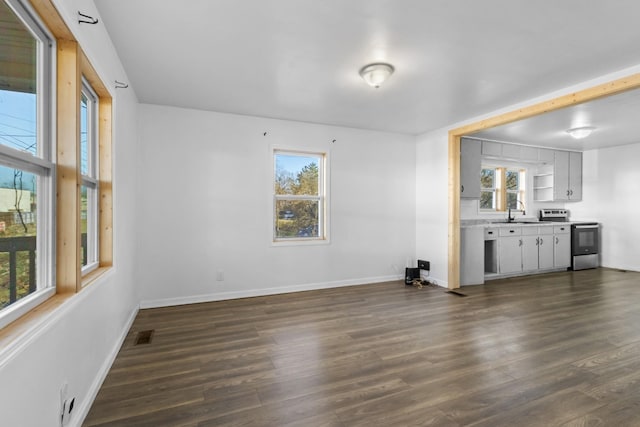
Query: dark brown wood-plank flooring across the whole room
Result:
<box><xmin>84</xmin><ymin>269</ymin><xmax>640</xmax><ymax>427</ymax></box>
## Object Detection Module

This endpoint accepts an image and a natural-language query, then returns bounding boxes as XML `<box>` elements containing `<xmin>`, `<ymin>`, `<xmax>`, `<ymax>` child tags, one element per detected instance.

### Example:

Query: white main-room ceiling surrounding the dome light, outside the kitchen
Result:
<box><xmin>95</xmin><ymin>0</ymin><xmax>640</xmax><ymax>140</ymax></box>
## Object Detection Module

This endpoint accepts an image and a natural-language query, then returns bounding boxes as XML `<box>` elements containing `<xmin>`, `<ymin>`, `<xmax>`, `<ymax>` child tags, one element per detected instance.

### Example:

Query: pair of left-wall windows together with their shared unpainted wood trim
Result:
<box><xmin>0</xmin><ymin>0</ymin><xmax>113</xmax><ymax>328</ymax></box>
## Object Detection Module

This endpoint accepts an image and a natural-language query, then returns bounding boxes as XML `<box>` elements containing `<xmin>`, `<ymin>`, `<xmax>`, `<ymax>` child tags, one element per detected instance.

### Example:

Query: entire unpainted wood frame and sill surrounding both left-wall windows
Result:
<box><xmin>0</xmin><ymin>0</ymin><xmax>113</xmax><ymax>340</ymax></box>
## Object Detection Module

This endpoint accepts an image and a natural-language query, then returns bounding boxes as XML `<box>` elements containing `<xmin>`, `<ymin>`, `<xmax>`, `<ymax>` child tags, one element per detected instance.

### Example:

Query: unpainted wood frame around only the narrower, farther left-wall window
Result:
<box><xmin>56</xmin><ymin>40</ymin><xmax>113</xmax><ymax>293</ymax></box>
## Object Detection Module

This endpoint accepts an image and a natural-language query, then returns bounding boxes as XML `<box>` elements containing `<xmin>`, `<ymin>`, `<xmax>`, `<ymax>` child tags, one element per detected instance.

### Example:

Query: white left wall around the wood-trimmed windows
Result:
<box><xmin>0</xmin><ymin>0</ymin><xmax>138</xmax><ymax>427</ymax></box>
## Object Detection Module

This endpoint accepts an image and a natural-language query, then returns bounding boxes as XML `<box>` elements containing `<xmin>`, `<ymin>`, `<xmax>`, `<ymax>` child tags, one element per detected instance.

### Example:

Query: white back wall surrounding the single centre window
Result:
<box><xmin>139</xmin><ymin>105</ymin><xmax>415</xmax><ymax>307</ymax></box>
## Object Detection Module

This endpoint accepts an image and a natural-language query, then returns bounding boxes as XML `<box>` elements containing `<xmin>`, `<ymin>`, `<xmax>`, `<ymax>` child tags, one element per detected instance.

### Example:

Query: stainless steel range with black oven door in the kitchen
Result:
<box><xmin>540</xmin><ymin>209</ymin><xmax>600</xmax><ymax>270</ymax></box>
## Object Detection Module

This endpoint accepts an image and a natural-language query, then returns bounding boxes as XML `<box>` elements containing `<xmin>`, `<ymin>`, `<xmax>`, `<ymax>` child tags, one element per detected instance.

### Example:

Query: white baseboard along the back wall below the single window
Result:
<box><xmin>140</xmin><ymin>275</ymin><xmax>404</xmax><ymax>309</ymax></box>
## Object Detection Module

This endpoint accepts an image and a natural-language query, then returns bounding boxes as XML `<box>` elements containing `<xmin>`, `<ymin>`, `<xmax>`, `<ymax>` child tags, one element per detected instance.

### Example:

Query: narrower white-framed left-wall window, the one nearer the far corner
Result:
<box><xmin>80</xmin><ymin>79</ymin><xmax>99</xmax><ymax>274</ymax></box>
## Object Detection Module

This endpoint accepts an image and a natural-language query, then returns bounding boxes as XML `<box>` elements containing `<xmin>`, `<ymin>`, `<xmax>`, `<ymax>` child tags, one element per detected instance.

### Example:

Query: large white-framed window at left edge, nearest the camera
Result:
<box><xmin>0</xmin><ymin>0</ymin><xmax>55</xmax><ymax>327</ymax></box>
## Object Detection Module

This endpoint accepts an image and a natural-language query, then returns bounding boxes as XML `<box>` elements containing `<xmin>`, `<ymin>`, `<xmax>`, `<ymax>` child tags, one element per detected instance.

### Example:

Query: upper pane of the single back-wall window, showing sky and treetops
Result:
<box><xmin>275</xmin><ymin>153</ymin><xmax>320</xmax><ymax>196</ymax></box>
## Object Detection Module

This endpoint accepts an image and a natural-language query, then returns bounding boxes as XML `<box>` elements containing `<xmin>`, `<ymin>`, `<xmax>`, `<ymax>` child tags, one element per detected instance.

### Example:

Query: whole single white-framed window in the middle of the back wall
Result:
<box><xmin>273</xmin><ymin>150</ymin><xmax>327</xmax><ymax>242</ymax></box>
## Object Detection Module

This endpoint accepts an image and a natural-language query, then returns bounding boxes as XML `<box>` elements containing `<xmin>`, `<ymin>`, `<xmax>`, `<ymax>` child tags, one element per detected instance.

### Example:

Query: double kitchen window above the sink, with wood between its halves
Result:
<box><xmin>480</xmin><ymin>166</ymin><xmax>526</xmax><ymax>212</ymax></box>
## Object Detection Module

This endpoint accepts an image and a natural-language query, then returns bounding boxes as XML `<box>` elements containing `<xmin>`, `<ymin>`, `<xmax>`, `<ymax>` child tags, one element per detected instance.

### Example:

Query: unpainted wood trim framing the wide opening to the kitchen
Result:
<box><xmin>447</xmin><ymin>73</ymin><xmax>640</xmax><ymax>289</ymax></box>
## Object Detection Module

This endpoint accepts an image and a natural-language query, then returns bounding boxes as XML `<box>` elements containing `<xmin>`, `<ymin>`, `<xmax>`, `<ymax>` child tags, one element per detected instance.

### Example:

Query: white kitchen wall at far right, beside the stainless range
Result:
<box><xmin>568</xmin><ymin>143</ymin><xmax>640</xmax><ymax>271</ymax></box>
